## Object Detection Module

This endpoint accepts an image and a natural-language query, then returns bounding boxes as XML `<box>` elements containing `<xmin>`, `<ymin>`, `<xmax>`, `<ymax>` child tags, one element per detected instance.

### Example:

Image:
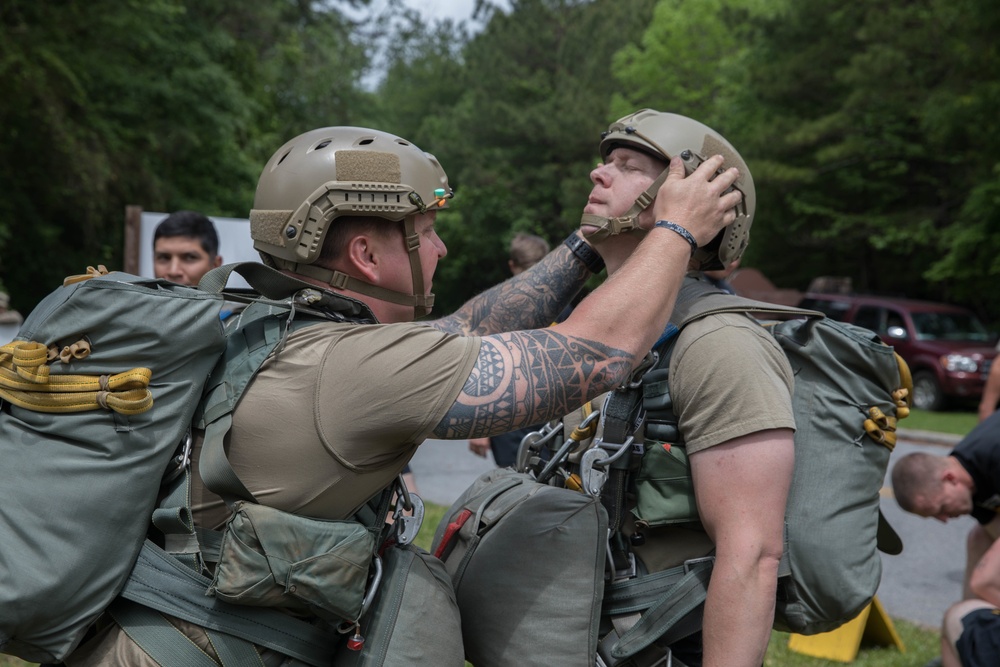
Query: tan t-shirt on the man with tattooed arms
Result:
<box><xmin>192</xmin><ymin>323</ymin><xmax>480</xmax><ymax>527</ymax></box>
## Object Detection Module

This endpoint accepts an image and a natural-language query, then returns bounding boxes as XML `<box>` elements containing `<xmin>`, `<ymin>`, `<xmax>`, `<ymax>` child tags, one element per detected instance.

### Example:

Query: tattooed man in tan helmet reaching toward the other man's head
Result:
<box><xmin>68</xmin><ymin>127</ymin><xmax>740</xmax><ymax>665</ymax></box>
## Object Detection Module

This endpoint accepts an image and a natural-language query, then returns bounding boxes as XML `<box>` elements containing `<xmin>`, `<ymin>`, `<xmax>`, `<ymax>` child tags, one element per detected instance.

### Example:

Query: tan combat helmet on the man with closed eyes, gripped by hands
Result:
<box><xmin>582</xmin><ymin>109</ymin><xmax>757</xmax><ymax>271</ymax></box>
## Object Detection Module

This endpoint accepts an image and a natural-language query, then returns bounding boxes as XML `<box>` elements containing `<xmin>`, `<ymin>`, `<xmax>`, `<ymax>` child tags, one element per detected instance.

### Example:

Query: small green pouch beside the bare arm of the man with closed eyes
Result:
<box><xmin>632</xmin><ymin>441</ymin><xmax>698</xmax><ymax>527</ymax></box>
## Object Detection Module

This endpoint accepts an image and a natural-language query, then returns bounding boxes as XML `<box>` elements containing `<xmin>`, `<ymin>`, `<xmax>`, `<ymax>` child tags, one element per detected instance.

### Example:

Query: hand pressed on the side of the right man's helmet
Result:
<box><xmin>643</xmin><ymin>155</ymin><xmax>743</xmax><ymax>246</ymax></box>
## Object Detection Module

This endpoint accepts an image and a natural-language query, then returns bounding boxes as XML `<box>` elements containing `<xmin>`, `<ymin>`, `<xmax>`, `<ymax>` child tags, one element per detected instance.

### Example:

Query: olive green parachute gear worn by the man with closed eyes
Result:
<box><xmin>434</xmin><ymin>279</ymin><xmax>912</xmax><ymax>667</ymax></box>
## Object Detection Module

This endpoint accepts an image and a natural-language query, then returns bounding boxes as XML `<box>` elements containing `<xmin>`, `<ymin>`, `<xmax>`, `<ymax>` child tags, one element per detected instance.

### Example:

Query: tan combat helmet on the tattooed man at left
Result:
<box><xmin>250</xmin><ymin>127</ymin><xmax>453</xmax><ymax>317</ymax></box>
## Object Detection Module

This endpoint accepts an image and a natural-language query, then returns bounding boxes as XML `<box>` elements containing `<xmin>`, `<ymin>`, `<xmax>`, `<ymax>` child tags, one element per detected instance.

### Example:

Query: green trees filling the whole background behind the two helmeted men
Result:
<box><xmin>0</xmin><ymin>0</ymin><xmax>1000</xmax><ymax>320</ymax></box>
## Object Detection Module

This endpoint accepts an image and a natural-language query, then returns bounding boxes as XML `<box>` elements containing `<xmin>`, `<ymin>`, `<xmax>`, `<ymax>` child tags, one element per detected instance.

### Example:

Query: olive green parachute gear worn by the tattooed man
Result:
<box><xmin>0</xmin><ymin>263</ymin><xmax>462</xmax><ymax>667</ymax></box>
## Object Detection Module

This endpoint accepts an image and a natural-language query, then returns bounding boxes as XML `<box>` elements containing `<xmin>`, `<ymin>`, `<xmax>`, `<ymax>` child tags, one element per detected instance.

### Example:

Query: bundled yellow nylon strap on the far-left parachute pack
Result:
<box><xmin>0</xmin><ymin>341</ymin><xmax>153</xmax><ymax>415</ymax></box>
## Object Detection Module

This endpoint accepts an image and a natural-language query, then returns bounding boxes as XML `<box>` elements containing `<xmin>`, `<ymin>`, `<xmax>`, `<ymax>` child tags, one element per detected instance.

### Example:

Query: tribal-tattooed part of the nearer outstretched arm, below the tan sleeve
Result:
<box><xmin>434</xmin><ymin>329</ymin><xmax>634</xmax><ymax>439</ymax></box>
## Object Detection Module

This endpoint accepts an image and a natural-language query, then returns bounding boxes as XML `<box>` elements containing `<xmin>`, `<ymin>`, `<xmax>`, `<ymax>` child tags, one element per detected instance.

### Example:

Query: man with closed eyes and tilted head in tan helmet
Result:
<box><xmin>568</xmin><ymin>109</ymin><xmax>795</xmax><ymax>667</ymax></box>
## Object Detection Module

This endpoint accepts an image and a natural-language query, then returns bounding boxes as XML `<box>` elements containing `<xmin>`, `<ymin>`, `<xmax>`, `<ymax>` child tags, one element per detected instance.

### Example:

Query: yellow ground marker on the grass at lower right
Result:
<box><xmin>788</xmin><ymin>597</ymin><xmax>906</xmax><ymax>662</ymax></box>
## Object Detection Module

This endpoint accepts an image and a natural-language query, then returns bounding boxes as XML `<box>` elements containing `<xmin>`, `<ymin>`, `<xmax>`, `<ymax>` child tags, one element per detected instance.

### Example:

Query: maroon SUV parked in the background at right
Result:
<box><xmin>799</xmin><ymin>292</ymin><xmax>997</xmax><ymax>410</ymax></box>
